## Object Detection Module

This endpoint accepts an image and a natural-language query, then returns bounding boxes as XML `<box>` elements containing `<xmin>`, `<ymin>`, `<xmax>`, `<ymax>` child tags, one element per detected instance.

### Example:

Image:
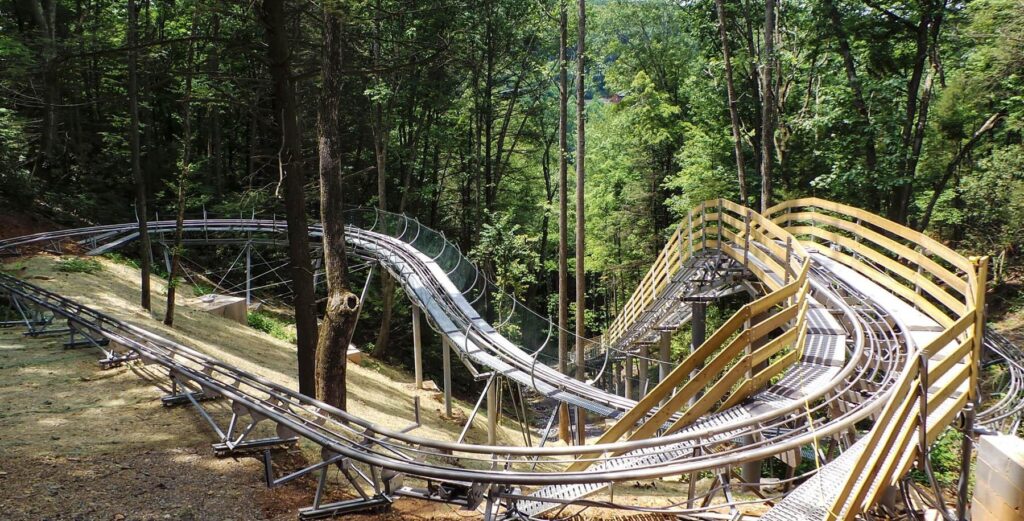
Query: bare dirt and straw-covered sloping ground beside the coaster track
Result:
<box><xmin>0</xmin><ymin>255</ymin><xmax>753</xmax><ymax>520</ymax></box>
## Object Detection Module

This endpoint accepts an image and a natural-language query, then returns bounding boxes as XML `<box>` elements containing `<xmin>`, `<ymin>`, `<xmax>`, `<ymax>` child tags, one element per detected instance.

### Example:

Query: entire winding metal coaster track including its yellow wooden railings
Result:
<box><xmin>0</xmin><ymin>200</ymin><xmax>1019</xmax><ymax>519</ymax></box>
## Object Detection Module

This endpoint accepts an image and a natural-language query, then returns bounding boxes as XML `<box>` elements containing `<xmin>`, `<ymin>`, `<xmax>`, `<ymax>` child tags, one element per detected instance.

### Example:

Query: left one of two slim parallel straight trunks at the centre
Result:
<box><xmin>558</xmin><ymin>0</ymin><xmax>569</xmax><ymax>443</ymax></box>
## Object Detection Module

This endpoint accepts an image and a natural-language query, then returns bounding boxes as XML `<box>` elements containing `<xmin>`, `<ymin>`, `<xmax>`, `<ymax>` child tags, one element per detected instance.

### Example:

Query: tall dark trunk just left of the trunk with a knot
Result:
<box><xmin>260</xmin><ymin>0</ymin><xmax>316</xmax><ymax>396</ymax></box>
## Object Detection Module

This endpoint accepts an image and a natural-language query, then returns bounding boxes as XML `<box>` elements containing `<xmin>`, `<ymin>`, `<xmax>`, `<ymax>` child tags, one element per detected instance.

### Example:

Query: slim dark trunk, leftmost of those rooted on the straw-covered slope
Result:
<box><xmin>128</xmin><ymin>0</ymin><xmax>153</xmax><ymax>309</ymax></box>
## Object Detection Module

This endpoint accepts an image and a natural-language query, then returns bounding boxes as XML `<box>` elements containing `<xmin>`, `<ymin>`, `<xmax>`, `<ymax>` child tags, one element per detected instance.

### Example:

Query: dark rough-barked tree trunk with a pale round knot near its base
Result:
<box><xmin>316</xmin><ymin>3</ymin><xmax>359</xmax><ymax>409</ymax></box>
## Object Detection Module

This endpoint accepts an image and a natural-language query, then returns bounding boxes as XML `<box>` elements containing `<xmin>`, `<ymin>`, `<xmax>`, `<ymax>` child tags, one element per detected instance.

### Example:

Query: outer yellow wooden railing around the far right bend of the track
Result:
<box><xmin>766</xmin><ymin>199</ymin><xmax>988</xmax><ymax>520</ymax></box>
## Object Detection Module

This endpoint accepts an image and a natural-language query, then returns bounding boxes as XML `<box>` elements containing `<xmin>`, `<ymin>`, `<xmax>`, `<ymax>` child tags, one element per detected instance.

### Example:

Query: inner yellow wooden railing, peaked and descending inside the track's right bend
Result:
<box><xmin>568</xmin><ymin>200</ymin><xmax>809</xmax><ymax>471</ymax></box>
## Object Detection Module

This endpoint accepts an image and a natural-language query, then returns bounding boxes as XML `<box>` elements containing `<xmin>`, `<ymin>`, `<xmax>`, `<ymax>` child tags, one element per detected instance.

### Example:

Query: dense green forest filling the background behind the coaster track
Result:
<box><xmin>0</xmin><ymin>0</ymin><xmax>1024</xmax><ymax>399</ymax></box>
